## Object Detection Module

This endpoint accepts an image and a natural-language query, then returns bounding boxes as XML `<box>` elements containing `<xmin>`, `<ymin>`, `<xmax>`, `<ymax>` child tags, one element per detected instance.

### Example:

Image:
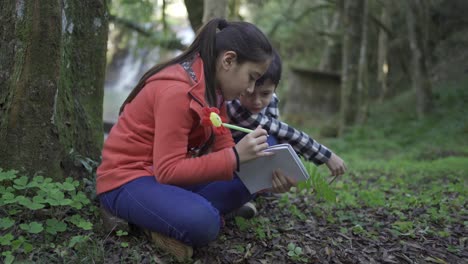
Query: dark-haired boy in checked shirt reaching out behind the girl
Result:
<box><xmin>227</xmin><ymin>51</ymin><xmax>346</xmax><ymax>217</ymax></box>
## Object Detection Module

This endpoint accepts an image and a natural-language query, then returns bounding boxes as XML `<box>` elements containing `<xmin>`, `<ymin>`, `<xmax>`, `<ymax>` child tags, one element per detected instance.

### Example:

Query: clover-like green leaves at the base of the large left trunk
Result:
<box><xmin>0</xmin><ymin>169</ymin><xmax>93</xmax><ymax>263</ymax></box>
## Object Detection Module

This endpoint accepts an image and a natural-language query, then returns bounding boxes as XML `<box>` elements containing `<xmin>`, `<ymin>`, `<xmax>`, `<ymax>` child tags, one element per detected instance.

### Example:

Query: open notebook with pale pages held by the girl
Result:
<box><xmin>238</xmin><ymin>144</ymin><xmax>309</xmax><ymax>194</ymax></box>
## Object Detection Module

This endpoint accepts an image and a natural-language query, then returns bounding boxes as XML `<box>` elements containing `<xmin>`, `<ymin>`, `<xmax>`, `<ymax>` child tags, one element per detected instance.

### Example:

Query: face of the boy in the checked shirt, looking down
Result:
<box><xmin>239</xmin><ymin>79</ymin><xmax>276</xmax><ymax>114</ymax></box>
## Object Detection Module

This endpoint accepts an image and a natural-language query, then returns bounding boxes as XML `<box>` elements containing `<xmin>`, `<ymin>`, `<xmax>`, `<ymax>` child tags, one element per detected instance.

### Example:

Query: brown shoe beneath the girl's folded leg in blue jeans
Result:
<box><xmin>144</xmin><ymin>229</ymin><xmax>193</xmax><ymax>262</ymax></box>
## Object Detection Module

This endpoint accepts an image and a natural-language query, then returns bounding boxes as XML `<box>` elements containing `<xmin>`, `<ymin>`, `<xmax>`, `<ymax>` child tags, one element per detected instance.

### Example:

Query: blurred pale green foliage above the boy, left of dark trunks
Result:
<box><xmin>249</xmin><ymin>0</ymin><xmax>334</xmax><ymax>67</ymax></box>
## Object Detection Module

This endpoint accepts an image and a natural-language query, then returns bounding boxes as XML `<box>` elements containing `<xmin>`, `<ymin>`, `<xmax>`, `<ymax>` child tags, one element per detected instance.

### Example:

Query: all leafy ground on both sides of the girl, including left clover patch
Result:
<box><xmin>0</xmin><ymin>81</ymin><xmax>468</xmax><ymax>263</ymax></box>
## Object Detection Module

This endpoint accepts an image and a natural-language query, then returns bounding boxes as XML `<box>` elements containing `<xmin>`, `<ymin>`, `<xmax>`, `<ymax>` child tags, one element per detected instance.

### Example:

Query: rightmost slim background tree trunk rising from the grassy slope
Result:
<box><xmin>406</xmin><ymin>0</ymin><xmax>432</xmax><ymax>118</ymax></box>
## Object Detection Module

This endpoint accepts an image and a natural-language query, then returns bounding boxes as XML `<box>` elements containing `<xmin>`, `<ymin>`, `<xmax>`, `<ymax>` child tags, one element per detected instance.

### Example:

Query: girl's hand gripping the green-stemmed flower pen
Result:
<box><xmin>235</xmin><ymin>126</ymin><xmax>273</xmax><ymax>163</ymax></box>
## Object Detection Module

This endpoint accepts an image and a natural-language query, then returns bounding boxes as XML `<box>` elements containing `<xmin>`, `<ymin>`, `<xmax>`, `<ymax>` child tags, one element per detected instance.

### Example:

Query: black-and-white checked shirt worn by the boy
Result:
<box><xmin>227</xmin><ymin>94</ymin><xmax>331</xmax><ymax>165</ymax></box>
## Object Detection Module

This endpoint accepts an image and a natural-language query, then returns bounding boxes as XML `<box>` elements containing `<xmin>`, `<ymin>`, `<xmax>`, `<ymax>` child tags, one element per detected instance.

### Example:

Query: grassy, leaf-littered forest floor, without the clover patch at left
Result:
<box><xmin>91</xmin><ymin>76</ymin><xmax>468</xmax><ymax>263</ymax></box>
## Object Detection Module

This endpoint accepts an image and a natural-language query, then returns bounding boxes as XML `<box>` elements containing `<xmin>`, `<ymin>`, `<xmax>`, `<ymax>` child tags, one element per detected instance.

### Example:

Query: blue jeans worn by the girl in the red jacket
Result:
<box><xmin>99</xmin><ymin>176</ymin><xmax>253</xmax><ymax>246</ymax></box>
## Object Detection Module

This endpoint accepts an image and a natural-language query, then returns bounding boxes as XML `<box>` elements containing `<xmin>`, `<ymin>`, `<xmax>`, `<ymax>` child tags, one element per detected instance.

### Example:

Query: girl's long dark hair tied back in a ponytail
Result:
<box><xmin>120</xmin><ymin>18</ymin><xmax>273</xmax><ymax>113</ymax></box>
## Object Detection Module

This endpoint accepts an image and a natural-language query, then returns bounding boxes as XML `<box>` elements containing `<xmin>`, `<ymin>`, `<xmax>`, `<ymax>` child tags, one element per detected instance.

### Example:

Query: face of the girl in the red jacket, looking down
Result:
<box><xmin>216</xmin><ymin>51</ymin><xmax>270</xmax><ymax>101</ymax></box>
